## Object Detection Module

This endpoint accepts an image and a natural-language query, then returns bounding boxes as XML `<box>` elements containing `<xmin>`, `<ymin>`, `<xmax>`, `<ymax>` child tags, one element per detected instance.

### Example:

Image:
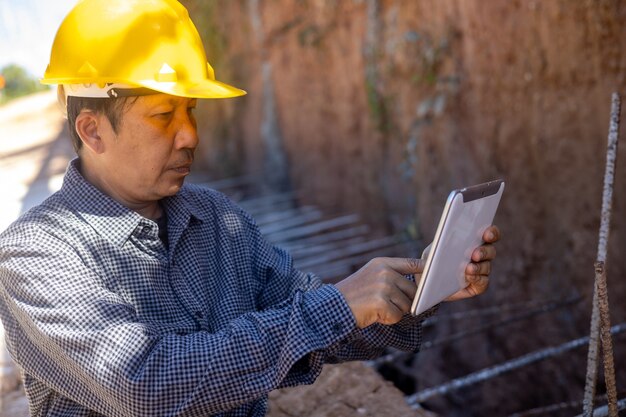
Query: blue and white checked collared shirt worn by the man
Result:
<box><xmin>0</xmin><ymin>159</ymin><xmax>423</xmax><ymax>417</ymax></box>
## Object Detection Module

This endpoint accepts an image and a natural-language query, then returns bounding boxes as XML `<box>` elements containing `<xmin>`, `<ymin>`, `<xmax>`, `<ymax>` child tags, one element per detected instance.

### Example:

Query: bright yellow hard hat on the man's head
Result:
<box><xmin>41</xmin><ymin>0</ymin><xmax>246</xmax><ymax>98</ymax></box>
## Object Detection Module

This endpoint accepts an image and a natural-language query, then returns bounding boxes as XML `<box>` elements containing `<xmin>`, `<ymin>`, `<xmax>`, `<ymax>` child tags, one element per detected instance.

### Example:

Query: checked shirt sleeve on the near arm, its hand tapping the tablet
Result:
<box><xmin>0</xmin><ymin>230</ymin><xmax>355</xmax><ymax>417</ymax></box>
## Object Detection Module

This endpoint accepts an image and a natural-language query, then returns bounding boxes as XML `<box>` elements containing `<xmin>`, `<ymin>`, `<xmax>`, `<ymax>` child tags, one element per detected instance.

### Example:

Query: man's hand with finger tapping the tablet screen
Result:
<box><xmin>335</xmin><ymin>258</ymin><xmax>424</xmax><ymax>329</ymax></box>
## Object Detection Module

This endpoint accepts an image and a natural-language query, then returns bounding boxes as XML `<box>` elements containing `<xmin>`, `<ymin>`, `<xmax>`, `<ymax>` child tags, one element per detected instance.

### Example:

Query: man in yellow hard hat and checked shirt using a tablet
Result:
<box><xmin>0</xmin><ymin>0</ymin><xmax>499</xmax><ymax>417</ymax></box>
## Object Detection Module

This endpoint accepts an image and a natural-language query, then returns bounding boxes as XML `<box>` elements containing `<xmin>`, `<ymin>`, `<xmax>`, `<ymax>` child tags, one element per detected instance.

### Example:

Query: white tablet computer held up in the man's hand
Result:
<box><xmin>411</xmin><ymin>180</ymin><xmax>504</xmax><ymax>315</ymax></box>
